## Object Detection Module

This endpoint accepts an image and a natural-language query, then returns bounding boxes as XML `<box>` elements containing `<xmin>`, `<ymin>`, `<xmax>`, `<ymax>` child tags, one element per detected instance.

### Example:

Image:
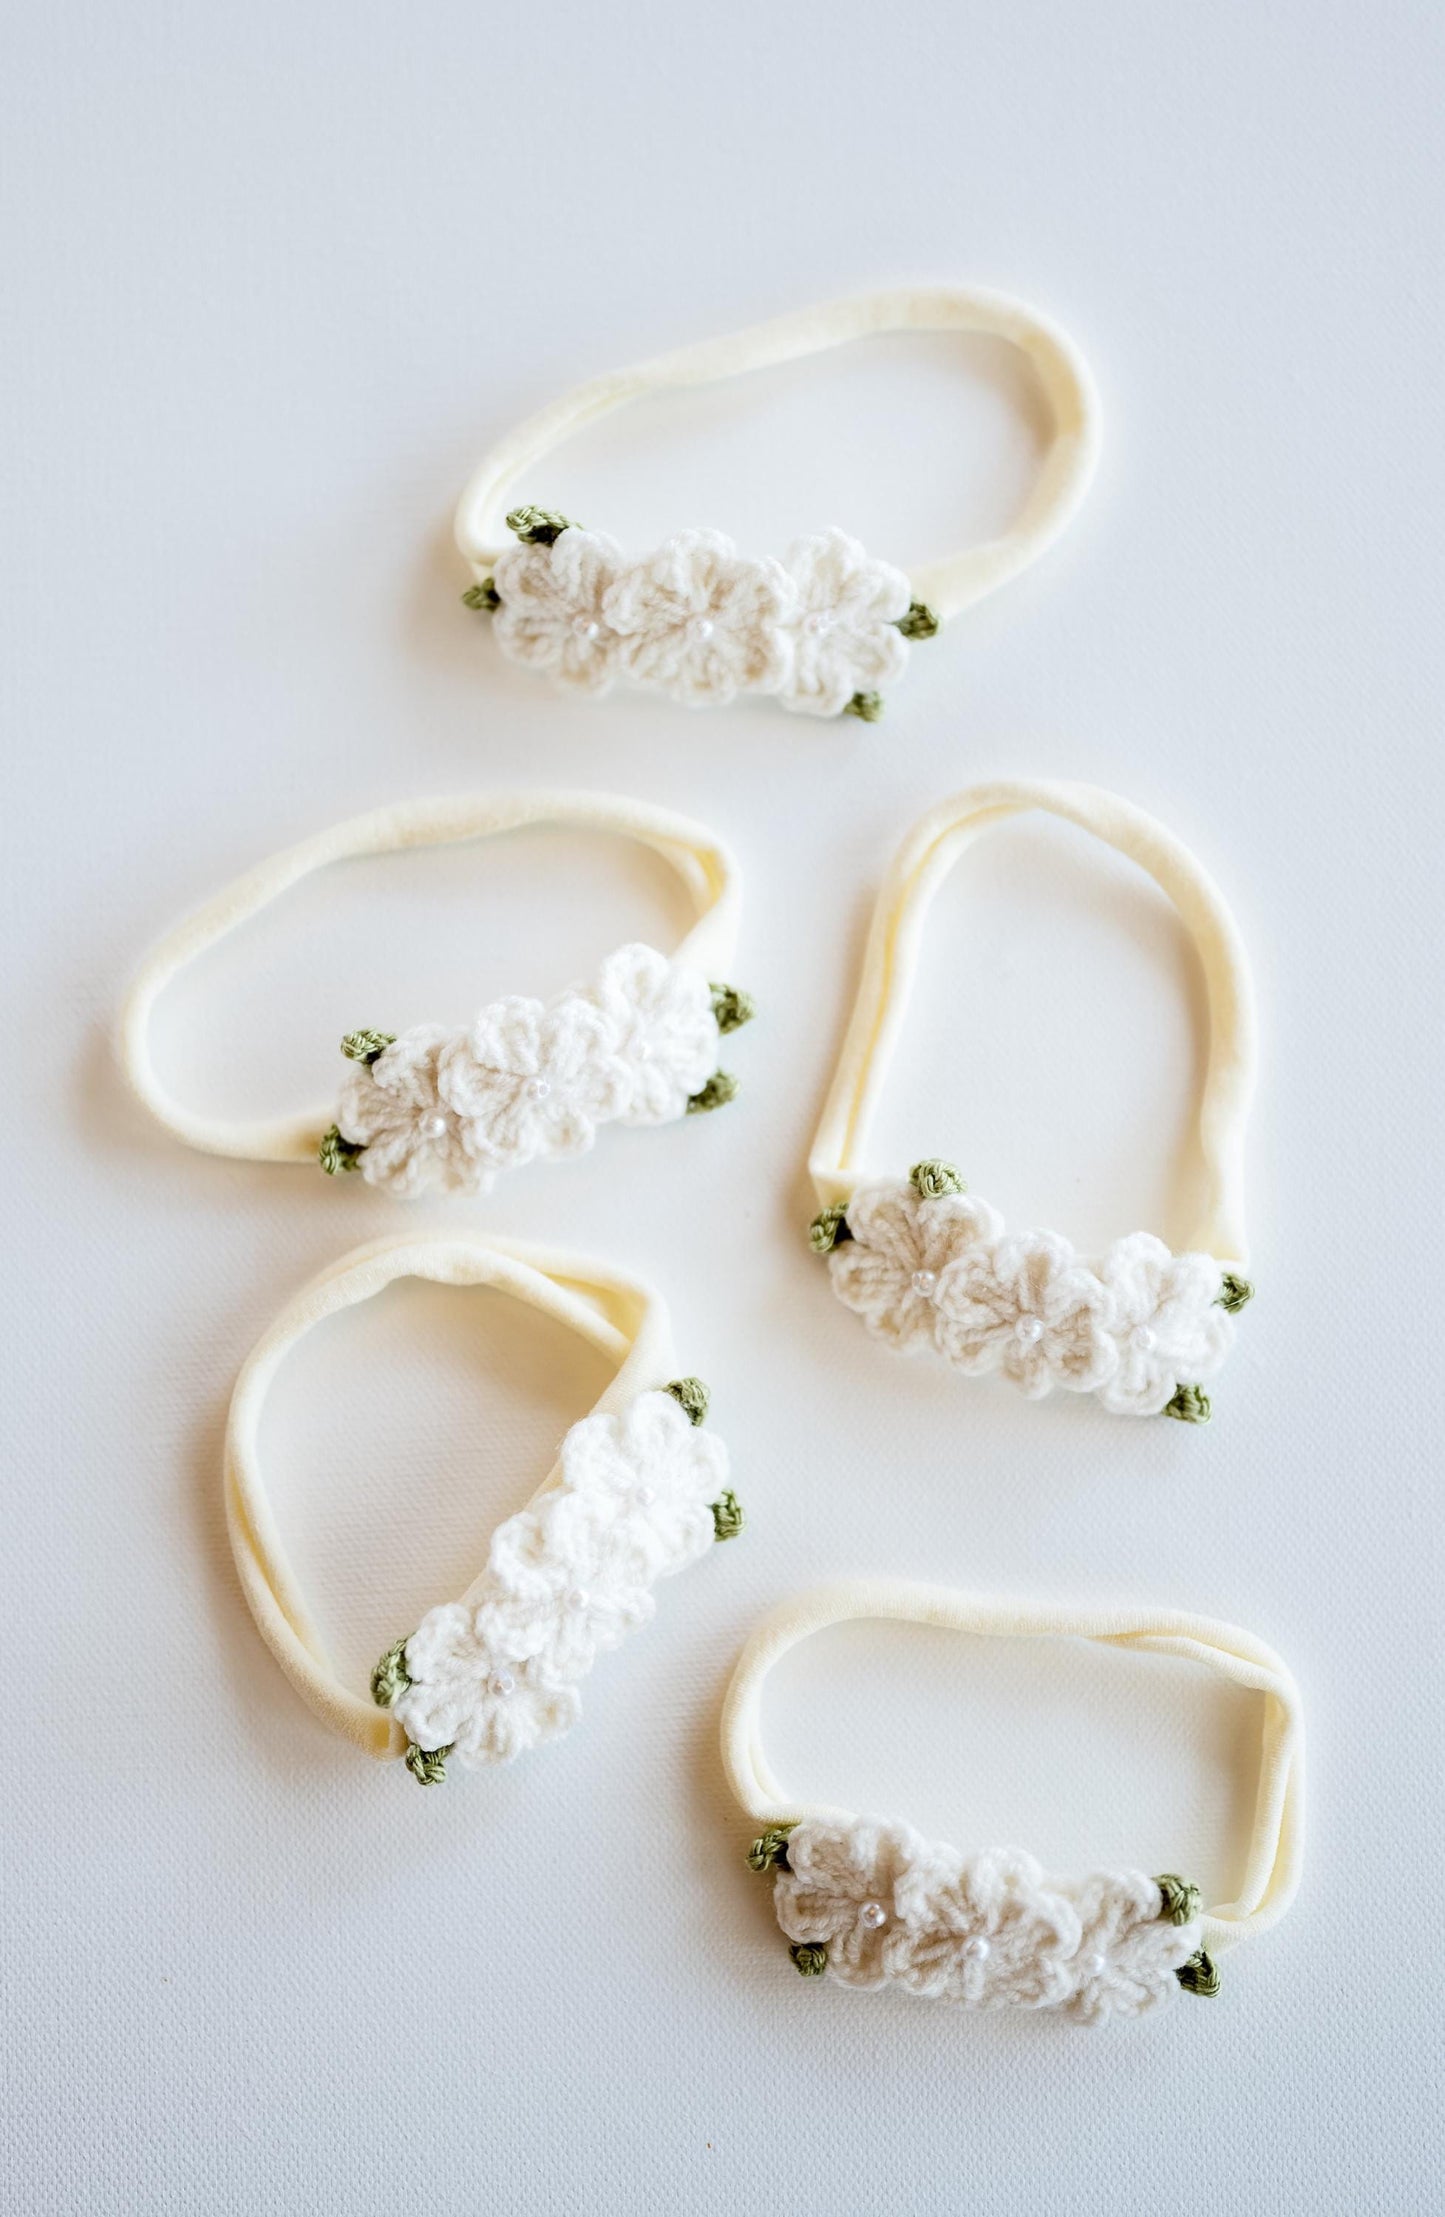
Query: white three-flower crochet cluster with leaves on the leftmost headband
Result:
<box><xmin>321</xmin><ymin>944</ymin><xmax>751</xmax><ymax>1199</ymax></box>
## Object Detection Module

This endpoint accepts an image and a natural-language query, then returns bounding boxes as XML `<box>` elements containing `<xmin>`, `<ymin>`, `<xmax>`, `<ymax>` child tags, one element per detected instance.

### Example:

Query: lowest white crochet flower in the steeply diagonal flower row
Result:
<box><xmin>392</xmin><ymin>1601</ymin><xmax>581</xmax><ymax>1763</ymax></box>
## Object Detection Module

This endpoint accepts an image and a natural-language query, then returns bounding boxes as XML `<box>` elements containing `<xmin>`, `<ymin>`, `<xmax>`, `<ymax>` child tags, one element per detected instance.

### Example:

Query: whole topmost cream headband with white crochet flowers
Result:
<box><xmin>457</xmin><ymin>286</ymin><xmax>1099</xmax><ymax>723</ymax></box>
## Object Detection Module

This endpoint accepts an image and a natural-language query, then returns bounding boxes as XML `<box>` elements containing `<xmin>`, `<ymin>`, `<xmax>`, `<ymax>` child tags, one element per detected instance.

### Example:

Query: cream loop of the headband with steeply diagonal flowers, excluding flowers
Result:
<box><xmin>226</xmin><ymin>1237</ymin><xmax>674</xmax><ymax>1758</ymax></box>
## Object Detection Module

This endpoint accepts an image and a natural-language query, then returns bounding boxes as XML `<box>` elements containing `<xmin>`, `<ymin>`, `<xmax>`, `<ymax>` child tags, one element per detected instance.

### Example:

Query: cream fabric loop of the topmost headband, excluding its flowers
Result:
<box><xmin>457</xmin><ymin>286</ymin><xmax>1099</xmax><ymax>616</ymax></box>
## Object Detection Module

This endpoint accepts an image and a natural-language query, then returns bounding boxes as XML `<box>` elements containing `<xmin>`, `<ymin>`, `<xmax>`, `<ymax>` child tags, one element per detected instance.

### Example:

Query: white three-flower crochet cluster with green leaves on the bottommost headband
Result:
<box><xmin>749</xmin><ymin>1818</ymin><xmax>1217</xmax><ymax>2024</ymax></box>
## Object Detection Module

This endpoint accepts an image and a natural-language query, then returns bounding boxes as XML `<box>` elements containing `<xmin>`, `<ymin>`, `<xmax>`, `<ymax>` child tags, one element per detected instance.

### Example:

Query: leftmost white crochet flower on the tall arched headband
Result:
<box><xmin>829</xmin><ymin>1184</ymin><xmax>1004</xmax><ymax>1355</ymax></box>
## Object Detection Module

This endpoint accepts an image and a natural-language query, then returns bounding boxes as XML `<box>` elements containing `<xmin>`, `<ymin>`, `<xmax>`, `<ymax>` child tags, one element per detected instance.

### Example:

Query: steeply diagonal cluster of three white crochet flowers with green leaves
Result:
<box><xmin>372</xmin><ymin>1379</ymin><xmax>742</xmax><ymax>1785</ymax></box>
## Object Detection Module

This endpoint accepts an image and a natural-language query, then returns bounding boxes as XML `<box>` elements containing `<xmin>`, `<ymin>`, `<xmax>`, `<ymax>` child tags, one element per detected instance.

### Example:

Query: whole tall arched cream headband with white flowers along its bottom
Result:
<box><xmin>809</xmin><ymin>778</ymin><xmax>1254</xmax><ymax>1423</ymax></box>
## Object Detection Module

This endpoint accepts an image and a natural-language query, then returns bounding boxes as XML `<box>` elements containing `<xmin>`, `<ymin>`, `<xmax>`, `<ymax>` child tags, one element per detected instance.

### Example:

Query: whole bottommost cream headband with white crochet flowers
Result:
<box><xmin>723</xmin><ymin>1579</ymin><xmax>1303</xmax><ymax>2022</ymax></box>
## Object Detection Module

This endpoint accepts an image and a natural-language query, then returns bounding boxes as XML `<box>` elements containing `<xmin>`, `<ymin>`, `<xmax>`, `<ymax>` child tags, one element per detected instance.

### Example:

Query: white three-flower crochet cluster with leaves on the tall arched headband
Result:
<box><xmin>811</xmin><ymin>1162</ymin><xmax>1252</xmax><ymax>1421</ymax></box>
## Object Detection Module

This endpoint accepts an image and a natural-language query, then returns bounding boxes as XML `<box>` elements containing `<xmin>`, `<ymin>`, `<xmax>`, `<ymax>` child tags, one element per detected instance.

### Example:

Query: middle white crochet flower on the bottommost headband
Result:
<box><xmin>893</xmin><ymin>1847</ymin><xmax>1081</xmax><ymax>2009</ymax></box>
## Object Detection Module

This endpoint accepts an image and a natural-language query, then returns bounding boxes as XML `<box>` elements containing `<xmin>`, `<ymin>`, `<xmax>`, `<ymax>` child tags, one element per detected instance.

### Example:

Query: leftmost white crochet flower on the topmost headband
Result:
<box><xmin>492</xmin><ymin>523</ymin><xmax>623</xmax><ymax>694</ymax></box>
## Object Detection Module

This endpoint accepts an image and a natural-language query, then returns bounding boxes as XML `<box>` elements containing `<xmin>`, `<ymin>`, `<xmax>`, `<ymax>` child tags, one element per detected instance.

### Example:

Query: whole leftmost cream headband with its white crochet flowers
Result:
<box><xmin>120</xmin><ymin>794</ymin><xmax>754</xmax><ymax>1199</ymax></box>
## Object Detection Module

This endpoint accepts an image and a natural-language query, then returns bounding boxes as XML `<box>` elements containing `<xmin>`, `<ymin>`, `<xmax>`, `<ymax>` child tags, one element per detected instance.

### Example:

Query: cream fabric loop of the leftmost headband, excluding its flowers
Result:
<box><xmin>120</xmin><ymin>791</ymin><xmax>740</xmax><ymax>1162</ymax></box>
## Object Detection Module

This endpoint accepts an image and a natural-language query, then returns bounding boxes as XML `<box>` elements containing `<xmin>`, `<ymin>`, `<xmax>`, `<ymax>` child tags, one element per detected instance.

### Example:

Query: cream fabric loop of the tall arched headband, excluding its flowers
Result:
<box><xmin>809</xmin><ymin>778</ymin><xmax>1257</xmax><ymax>1264</ymax></box>
